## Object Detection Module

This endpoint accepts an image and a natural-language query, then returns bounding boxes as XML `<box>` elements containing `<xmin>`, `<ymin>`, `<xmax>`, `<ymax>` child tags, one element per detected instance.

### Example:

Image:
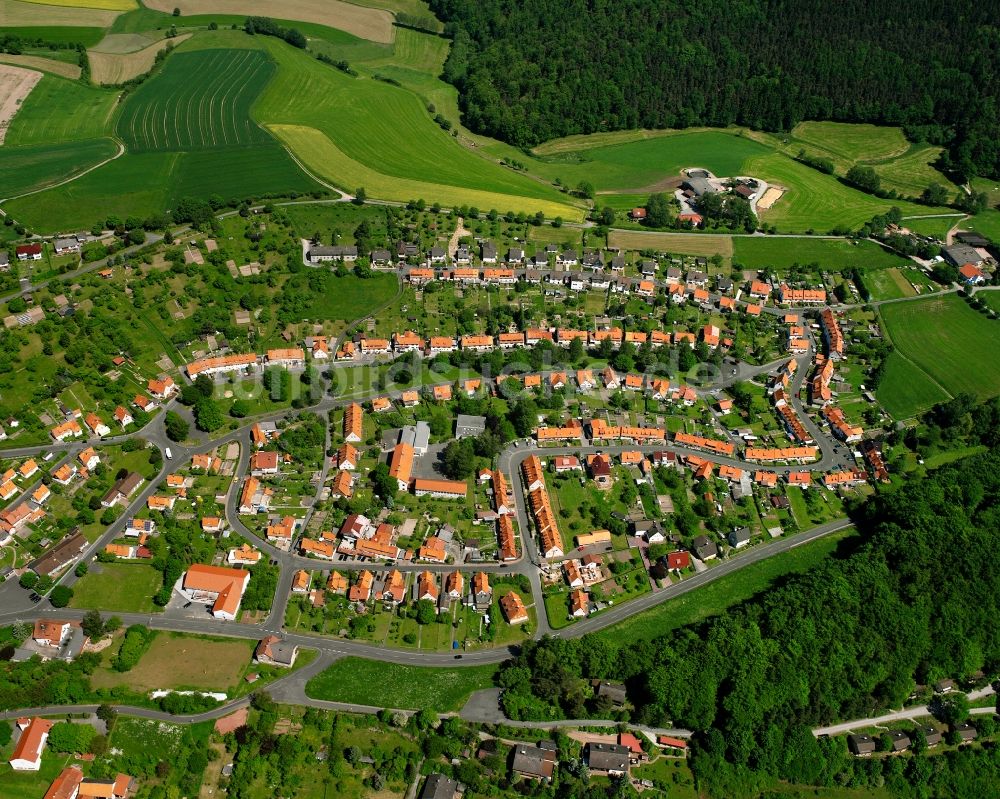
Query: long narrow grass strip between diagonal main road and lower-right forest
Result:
<box><xmin>596</xmin><ymin>528</ymin><xmax>857</xmax><ymax>646</ymax></box>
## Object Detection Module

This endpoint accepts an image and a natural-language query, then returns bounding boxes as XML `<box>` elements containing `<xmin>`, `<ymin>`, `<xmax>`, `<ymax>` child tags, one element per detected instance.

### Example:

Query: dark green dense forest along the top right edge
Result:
<box><xmin>430</xmin><ymin>0</ymin><xmax>1000</xmax><ymax>177</ymax></box>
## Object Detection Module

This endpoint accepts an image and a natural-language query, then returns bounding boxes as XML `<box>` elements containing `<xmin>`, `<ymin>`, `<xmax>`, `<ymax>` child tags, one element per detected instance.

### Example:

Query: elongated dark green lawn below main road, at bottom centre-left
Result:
<box><xmin>306</xmin><ymin>657</ymin><xmax>497</xmax><ymax>712</ymax></box>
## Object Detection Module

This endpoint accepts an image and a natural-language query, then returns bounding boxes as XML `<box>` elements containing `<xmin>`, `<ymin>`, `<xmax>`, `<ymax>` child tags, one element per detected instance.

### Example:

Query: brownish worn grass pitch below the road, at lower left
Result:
<box><xmin>90</xmin><ymin>632</ymin><xmax>255</xmax><ymax>692</ymax></box>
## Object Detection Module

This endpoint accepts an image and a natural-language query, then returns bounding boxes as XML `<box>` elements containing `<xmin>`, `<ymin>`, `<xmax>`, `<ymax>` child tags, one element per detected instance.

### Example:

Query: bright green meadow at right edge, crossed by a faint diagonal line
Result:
<box><xmin>877</xmin><ymin>294</ymin><xmax>1000</xmax><ymax>418</ymax></box>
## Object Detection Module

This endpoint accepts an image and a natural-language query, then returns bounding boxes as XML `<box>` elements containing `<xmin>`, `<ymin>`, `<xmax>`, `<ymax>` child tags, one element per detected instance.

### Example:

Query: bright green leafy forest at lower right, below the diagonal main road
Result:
<box><xmin>500</xmin><ymin>422</ymin><xmax>1000</xmax><ymax>797</ymax></box>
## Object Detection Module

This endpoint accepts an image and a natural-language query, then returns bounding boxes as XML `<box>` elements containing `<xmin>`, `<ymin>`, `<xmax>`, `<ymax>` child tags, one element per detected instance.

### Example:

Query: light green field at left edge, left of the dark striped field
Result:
<box><xmin>4</xmin><ymin>75</ymin><xmax>117</xmax><ymax>147</ymax></box>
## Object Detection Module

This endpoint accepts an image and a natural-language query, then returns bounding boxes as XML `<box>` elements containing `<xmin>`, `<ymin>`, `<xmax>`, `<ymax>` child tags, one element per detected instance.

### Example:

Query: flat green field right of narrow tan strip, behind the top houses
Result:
<box><xmin>733</xmin><ymin>236</ymin><xmax>910</xmax><ymax>270</ymax></box>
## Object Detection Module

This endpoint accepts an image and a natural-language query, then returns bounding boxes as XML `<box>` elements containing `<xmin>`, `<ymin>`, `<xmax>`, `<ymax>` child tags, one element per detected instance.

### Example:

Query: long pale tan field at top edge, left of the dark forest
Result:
<box><xmin>145</xmin><ymin>0</ymin><xmax>394</xmax><ymax>43</ymax></box>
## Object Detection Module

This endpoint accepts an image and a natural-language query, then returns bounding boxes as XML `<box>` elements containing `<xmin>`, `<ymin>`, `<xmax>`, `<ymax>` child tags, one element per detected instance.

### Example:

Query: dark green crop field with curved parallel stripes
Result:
<box><xmin>116</xmin><ymin>49</ymin><xmax>275</xmax><ymax>152</ymax></box>
